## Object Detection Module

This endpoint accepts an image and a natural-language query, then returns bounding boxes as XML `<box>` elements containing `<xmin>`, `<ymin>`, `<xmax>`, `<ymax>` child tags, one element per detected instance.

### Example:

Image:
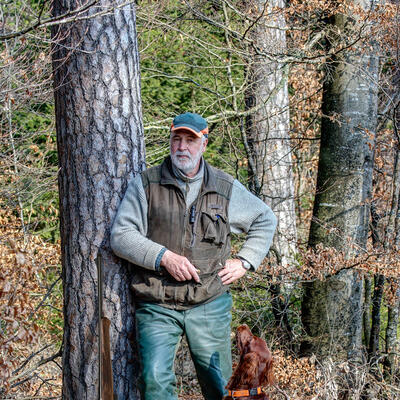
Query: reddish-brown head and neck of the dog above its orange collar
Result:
<box><xmin>228</xmin><ymin>325</ymin><xmax>274</xmax><ymax>387</ymax></box>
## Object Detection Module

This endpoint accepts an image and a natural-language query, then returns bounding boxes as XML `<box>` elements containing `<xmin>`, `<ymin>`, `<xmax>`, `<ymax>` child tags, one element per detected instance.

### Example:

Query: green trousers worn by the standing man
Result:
<box><xmin>136</xmin><ymin>293</ymin><xmax>232</xmax><ymax>400</ymax></box>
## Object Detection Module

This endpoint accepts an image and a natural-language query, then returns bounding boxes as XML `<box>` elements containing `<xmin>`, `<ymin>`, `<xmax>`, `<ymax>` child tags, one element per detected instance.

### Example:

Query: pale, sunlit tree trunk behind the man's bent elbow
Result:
<box><xmin>246</xmin><ymin>0</ymin><xmax>297</xmax><ymax>265</ymax></box>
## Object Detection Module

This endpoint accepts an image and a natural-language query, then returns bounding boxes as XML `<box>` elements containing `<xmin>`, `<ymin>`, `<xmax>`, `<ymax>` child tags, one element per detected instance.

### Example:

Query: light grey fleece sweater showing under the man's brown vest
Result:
<box><xmin>111</xmin><ymin>159</ymin><xmax>277</xmax><ymax>270</ymax></box>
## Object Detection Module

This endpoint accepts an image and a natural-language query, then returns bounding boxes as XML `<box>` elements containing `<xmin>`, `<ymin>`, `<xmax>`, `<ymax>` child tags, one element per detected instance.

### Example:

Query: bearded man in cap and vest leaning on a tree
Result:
<box><xmin>111</xmin><ymin>113</ymin><xmax>276</xmax><ymax>400</ymax></box>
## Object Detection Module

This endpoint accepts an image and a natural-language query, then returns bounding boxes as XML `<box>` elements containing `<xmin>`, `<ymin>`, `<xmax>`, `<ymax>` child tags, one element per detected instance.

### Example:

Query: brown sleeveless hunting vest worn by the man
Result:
<box><xmin>132</xmin><ymin>157</ymin><xmax>233</xmax><ymax>310</ymax></box>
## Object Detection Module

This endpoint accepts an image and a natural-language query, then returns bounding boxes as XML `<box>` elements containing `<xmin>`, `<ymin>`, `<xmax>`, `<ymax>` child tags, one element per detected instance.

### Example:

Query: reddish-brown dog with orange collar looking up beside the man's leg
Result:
<box><xmin>223</xmin><ymin>325</ymin><xmax>274</xmax><ymax>400</ymax></box>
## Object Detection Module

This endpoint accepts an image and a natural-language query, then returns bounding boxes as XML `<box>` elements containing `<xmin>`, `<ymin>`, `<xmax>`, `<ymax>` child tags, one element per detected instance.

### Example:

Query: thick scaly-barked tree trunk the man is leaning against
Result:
<box><xmin>52</xmin><ymin>0</ymin><xmax>144</xmax><ymax>400</ymax></box>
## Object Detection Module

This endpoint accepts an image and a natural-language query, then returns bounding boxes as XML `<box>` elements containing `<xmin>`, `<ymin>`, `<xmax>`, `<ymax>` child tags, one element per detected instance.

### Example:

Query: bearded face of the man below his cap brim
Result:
<box><xmin>170</xmin><ymin>129</ymin><xmax>208</xmax><ymax>177</ymax></box>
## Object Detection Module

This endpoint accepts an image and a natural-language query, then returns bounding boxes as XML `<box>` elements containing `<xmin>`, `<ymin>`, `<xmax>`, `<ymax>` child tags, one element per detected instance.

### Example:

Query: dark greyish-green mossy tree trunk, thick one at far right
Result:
<box><xmin>302</xmin><ymin>5</ymin><xmax>378</xmax><ymax>358</ymax></box>
